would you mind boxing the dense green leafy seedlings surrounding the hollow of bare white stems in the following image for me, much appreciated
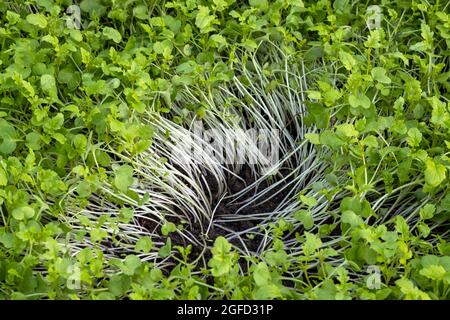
[0,0,450,299]
